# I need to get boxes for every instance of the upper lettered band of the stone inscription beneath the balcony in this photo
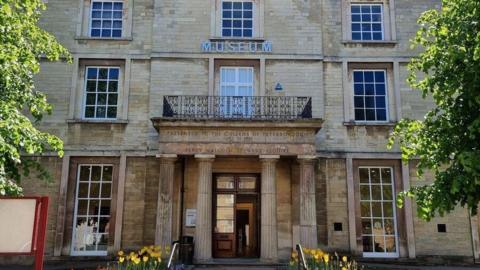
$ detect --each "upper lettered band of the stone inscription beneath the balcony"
[160,129,315,144]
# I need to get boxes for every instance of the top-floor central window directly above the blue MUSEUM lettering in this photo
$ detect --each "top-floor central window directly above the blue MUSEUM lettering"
[221,1,254,37]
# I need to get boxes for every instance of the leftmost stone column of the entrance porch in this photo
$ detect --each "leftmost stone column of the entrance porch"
[155,155,177,247]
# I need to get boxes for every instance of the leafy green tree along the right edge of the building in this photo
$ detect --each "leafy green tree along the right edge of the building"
[389,0,480,220]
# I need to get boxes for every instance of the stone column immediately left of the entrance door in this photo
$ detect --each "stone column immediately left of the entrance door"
[195,155,215,261]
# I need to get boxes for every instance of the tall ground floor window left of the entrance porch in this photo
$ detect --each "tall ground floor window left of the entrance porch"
[71,164,113,256]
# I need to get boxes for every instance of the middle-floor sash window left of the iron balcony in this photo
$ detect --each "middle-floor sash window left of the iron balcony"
[84,66,120,119]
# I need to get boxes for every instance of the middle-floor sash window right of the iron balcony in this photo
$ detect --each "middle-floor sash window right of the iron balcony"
[353,70,388,122]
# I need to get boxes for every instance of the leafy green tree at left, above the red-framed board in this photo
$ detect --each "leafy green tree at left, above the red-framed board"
[0,0,71,196]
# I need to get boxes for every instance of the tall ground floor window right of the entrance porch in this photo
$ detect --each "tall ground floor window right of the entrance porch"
[358,167,399,257]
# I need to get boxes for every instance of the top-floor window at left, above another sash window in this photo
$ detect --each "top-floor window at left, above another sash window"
[90,1,123,38]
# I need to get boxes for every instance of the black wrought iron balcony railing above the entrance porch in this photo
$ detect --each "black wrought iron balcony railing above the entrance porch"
[163,96,312,120]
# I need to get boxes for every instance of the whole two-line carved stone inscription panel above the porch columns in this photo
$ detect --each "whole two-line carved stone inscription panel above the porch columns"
[159,127,315,156]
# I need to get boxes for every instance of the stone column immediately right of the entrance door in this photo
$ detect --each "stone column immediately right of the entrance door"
[260,156,280,261]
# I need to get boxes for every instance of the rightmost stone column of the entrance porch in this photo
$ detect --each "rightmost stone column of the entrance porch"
[298,156,318,248]
